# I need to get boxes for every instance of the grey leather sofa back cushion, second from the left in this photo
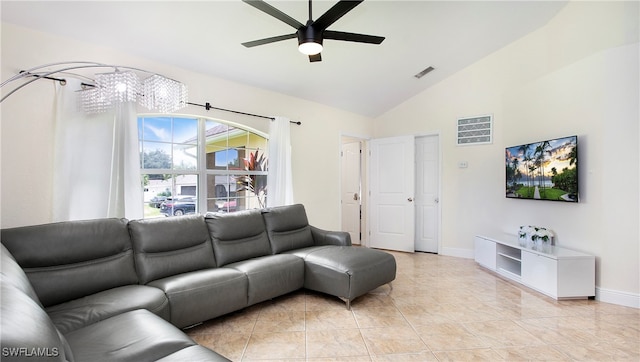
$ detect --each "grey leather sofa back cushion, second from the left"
[129,215,216,284]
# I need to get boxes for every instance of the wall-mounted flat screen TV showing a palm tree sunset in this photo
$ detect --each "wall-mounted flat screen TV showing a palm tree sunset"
[505,136,578,202]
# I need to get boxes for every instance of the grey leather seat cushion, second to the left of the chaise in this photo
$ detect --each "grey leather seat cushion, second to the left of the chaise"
[148,268,248,328]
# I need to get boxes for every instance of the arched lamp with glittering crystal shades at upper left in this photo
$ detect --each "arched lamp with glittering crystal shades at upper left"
[0,61,188,114]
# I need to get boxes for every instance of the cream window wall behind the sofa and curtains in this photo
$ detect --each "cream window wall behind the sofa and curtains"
[0,23,372,230]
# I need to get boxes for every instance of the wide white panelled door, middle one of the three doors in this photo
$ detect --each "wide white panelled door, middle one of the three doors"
[369,136,415,252]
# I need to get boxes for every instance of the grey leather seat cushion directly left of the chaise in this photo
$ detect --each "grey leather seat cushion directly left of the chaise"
[223,254,304,305]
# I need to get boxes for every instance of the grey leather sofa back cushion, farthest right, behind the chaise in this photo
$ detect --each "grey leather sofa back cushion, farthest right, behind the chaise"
[262,204,314,254]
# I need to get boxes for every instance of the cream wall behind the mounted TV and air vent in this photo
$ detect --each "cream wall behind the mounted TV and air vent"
[374,2,640,307]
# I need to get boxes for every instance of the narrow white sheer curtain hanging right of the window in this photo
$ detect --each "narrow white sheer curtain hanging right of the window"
[267,117,293,207]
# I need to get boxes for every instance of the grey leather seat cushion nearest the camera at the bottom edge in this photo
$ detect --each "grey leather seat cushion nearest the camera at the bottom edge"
[66,309,196,362]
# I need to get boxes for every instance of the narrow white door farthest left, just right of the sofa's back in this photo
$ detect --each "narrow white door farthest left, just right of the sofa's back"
[341,142,361,244]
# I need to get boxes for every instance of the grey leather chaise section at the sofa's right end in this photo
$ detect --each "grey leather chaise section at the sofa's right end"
[304,246,396,301]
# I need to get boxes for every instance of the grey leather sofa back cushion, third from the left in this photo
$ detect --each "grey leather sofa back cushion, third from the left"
[205,210,271,266]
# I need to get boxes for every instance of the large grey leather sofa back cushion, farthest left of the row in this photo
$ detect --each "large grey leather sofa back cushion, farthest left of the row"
[1,218,138,307]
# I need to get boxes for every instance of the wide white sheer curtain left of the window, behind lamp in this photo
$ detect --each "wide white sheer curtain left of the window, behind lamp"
[53,79,143,221]
